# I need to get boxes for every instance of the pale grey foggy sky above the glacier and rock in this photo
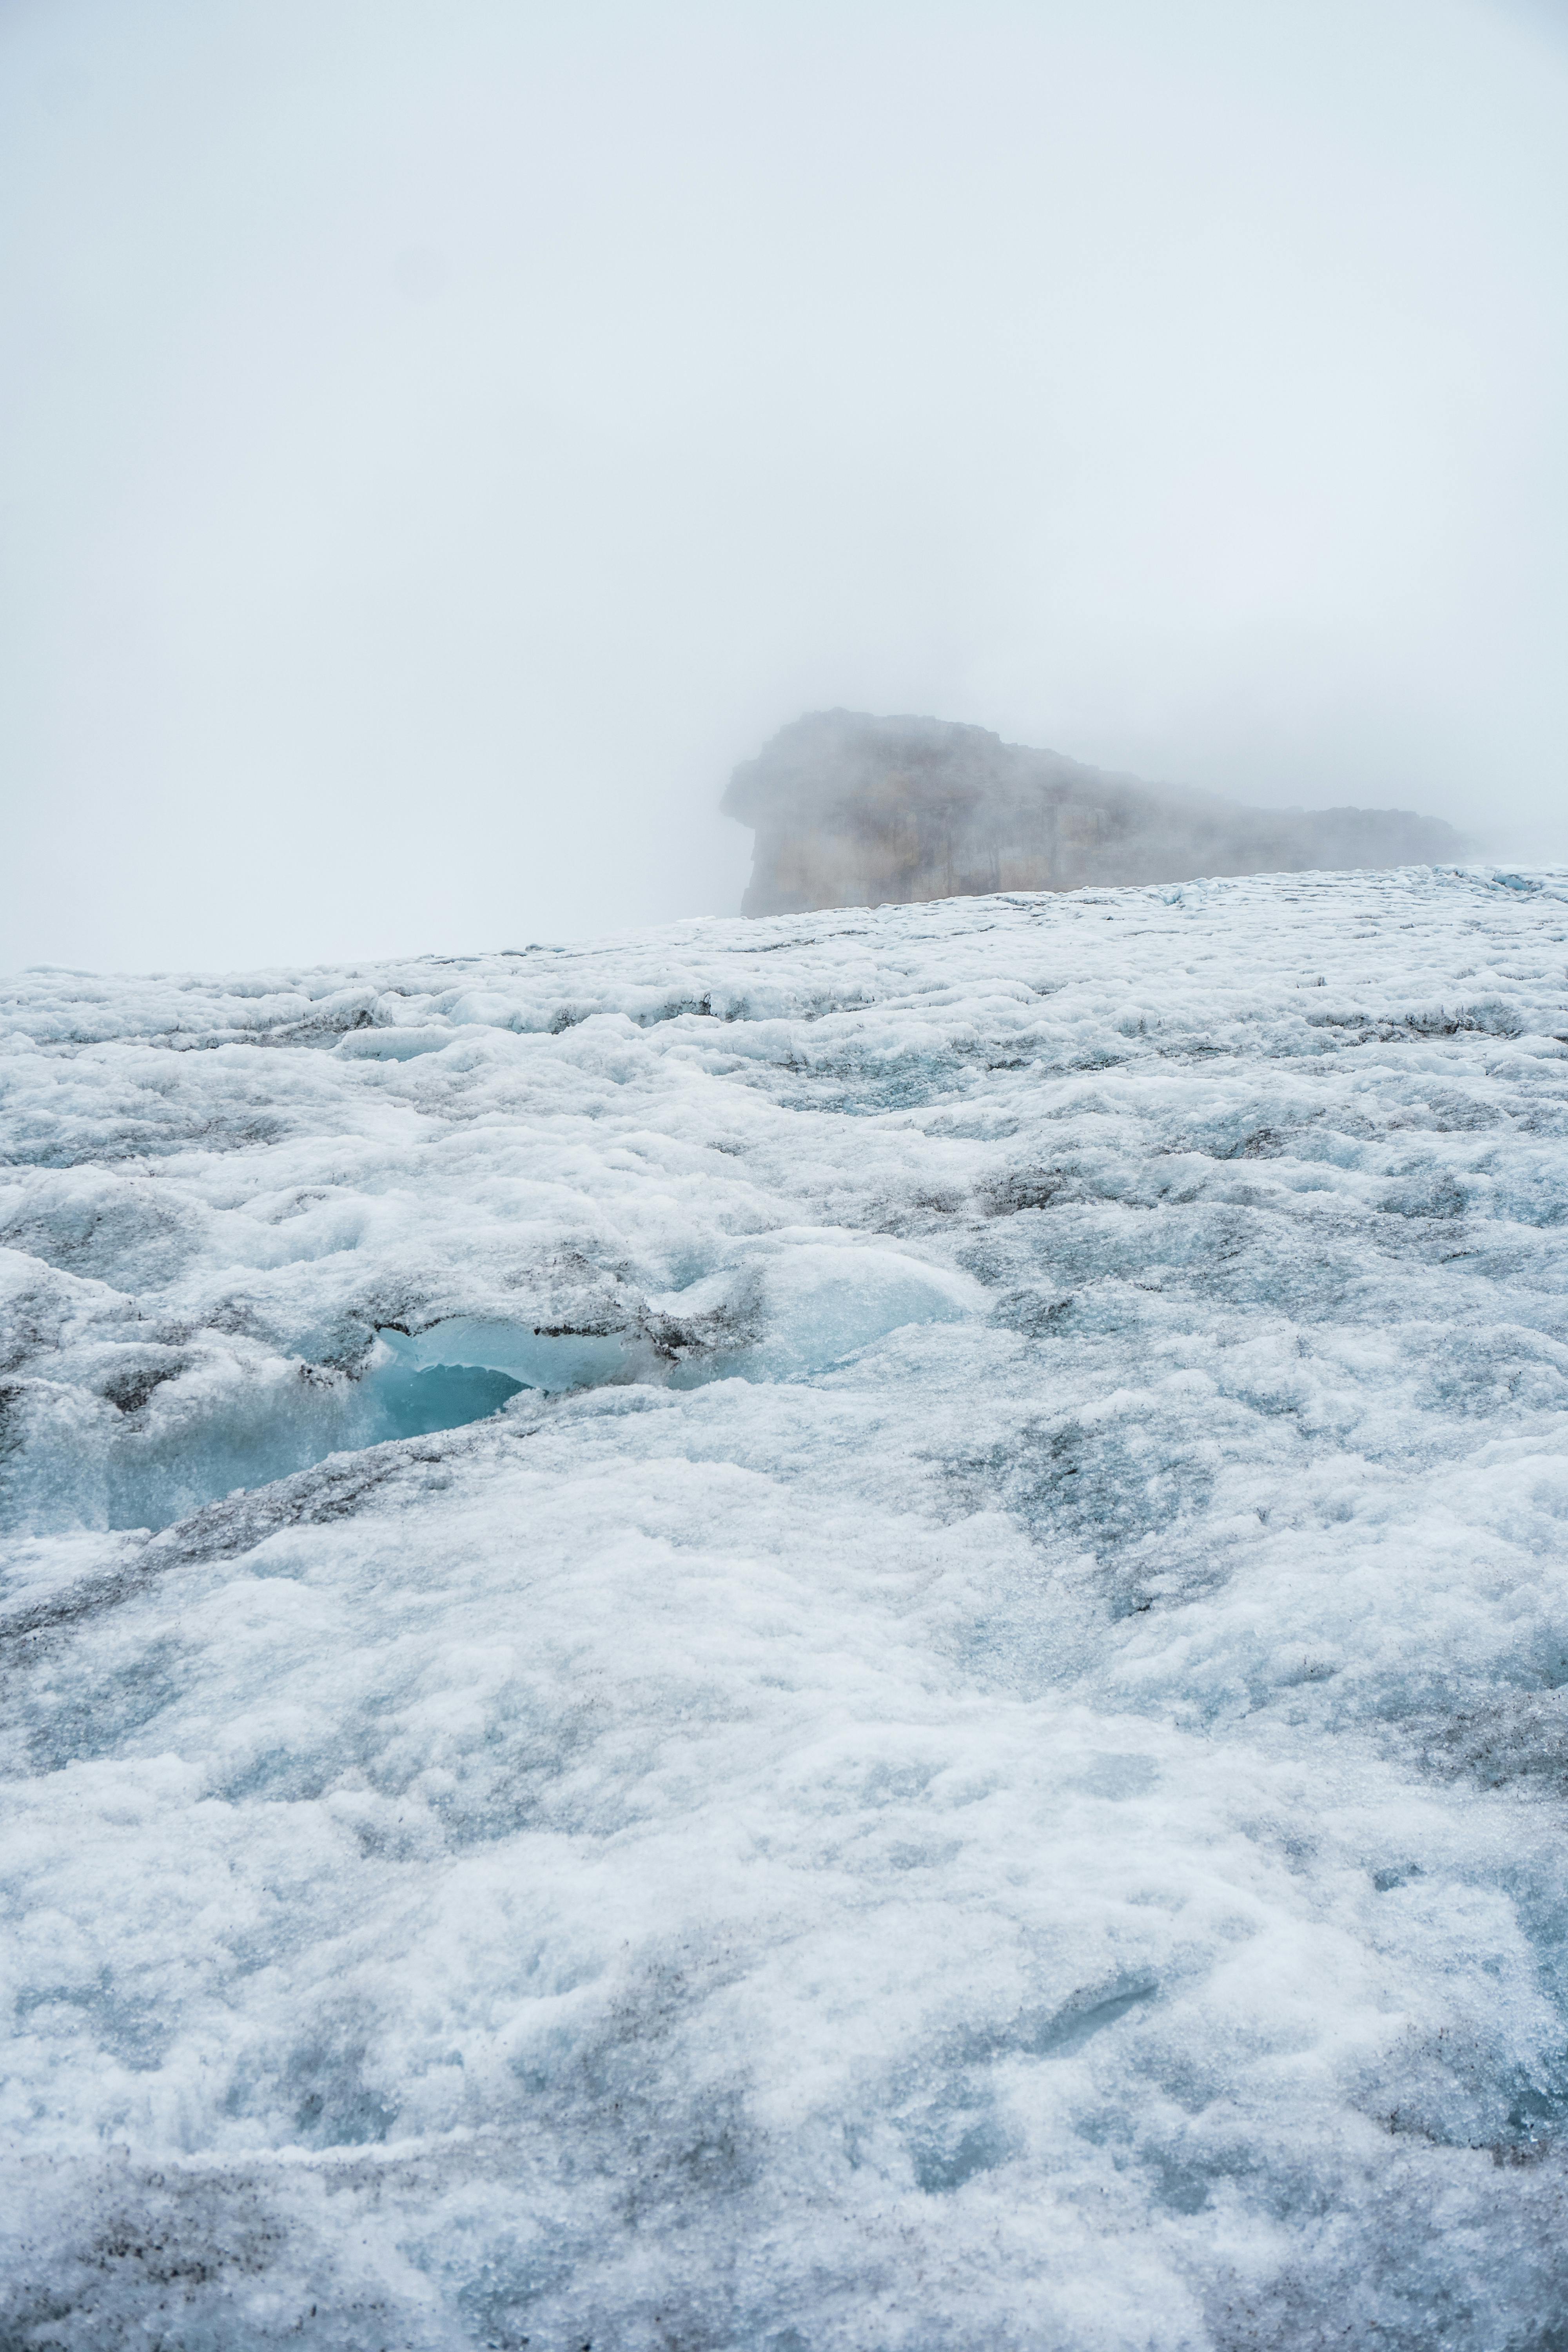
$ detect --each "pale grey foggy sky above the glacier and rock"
[0,0,1568,969]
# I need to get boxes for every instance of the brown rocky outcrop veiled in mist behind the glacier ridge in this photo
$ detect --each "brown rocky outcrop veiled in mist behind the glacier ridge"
[724,710,1462,915]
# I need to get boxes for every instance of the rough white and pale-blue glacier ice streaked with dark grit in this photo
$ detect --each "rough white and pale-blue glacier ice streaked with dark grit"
[0,870,1568,2352]
